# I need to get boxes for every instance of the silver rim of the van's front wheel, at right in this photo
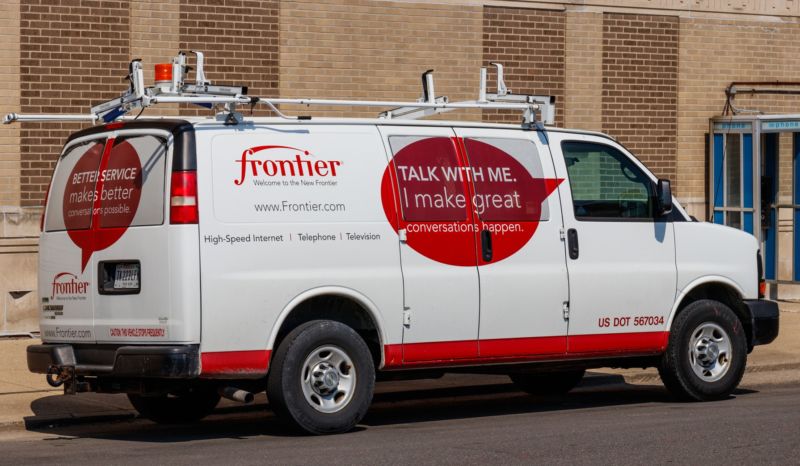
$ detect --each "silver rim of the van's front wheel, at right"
[689,322,733,382]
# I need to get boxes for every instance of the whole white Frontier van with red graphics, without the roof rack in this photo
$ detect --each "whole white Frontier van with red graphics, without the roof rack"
[14,54,778,433]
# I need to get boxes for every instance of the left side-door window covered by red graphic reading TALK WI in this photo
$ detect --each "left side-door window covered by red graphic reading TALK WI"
[389,136,468,222]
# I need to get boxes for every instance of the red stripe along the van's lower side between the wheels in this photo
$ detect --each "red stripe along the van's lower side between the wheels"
[384,332,669,369]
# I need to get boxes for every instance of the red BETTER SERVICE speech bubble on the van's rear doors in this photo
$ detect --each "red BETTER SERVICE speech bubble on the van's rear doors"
[62,140,143,272]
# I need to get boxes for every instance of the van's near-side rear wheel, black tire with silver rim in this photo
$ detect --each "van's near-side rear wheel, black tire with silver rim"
[267,320,375,435]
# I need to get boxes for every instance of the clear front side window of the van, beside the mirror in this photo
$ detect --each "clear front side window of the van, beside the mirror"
[561,141,655,220]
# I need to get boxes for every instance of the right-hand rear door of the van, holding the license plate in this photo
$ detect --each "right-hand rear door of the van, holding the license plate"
[92,131,173,342]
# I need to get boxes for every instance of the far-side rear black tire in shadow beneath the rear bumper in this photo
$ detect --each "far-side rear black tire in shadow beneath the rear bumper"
[128,386,220,424]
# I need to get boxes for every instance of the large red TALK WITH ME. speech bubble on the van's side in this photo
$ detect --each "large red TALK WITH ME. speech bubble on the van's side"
[381,137,563,267]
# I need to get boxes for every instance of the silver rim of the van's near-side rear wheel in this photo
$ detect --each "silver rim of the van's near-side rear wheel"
[300,345,356,413]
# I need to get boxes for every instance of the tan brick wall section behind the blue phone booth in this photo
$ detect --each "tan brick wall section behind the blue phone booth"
[677,18,800,217]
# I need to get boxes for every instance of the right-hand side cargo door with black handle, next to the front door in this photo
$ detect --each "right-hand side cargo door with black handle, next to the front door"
[456,128,569,359]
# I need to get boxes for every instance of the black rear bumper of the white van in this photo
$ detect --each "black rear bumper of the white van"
[28,343,200,379]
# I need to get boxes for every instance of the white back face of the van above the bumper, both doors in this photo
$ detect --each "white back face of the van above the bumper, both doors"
[40,124,199,343]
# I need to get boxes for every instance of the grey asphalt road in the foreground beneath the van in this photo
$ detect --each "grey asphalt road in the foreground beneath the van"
[0,374,800,465]
